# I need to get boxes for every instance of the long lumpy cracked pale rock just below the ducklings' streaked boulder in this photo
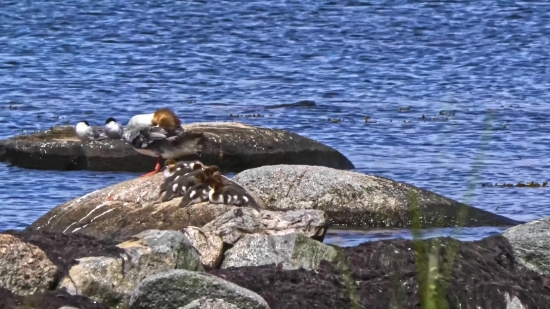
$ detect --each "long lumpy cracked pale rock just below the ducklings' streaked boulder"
[203,207,328,245]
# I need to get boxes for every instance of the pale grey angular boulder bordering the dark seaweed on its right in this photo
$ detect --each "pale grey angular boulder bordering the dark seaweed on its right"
[221,234,337,269]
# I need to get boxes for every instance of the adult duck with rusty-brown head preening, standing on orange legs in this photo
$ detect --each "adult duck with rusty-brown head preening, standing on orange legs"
[122,108,203,177]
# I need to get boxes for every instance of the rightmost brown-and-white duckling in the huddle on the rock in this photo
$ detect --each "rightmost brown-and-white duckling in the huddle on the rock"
[205,177,260,209]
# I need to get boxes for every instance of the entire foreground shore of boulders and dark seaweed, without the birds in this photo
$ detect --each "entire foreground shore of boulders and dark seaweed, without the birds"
[0,162,550,309]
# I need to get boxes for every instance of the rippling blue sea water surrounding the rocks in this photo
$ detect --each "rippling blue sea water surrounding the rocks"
[0,0,550,245]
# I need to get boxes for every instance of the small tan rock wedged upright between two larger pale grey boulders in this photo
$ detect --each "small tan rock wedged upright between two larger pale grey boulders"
[183,226,223,268]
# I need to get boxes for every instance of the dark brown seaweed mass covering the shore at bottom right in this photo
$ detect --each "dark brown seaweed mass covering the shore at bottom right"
[211,236,550,309]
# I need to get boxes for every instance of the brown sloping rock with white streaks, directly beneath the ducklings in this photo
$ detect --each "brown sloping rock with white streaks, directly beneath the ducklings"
[26,173,246,242]
